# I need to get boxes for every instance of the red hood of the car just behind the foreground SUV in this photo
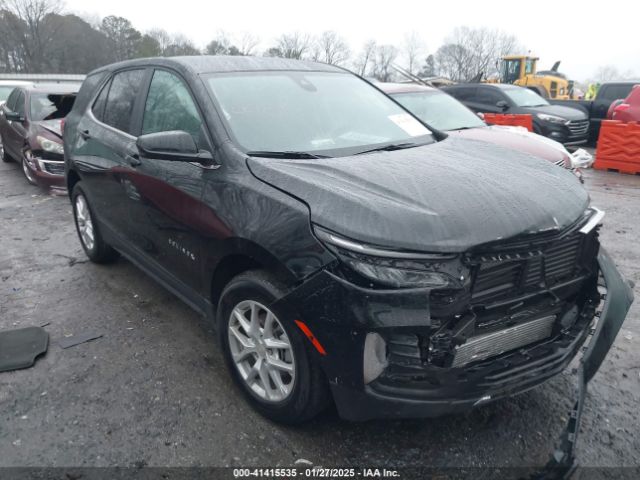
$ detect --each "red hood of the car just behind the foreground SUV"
[447,126,569,163]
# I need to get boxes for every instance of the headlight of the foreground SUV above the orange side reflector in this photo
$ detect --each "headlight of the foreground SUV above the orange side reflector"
[314,226,459,288]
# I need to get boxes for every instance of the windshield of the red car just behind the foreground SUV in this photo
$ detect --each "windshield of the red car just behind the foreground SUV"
[391,91,485,131]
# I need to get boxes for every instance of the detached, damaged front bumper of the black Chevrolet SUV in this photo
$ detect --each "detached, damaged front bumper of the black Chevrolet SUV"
[278,250,633,420]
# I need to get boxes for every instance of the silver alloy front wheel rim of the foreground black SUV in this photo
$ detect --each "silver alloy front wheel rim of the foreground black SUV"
[227,300,296,403]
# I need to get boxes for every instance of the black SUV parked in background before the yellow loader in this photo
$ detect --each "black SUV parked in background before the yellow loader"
[443,83,589,146]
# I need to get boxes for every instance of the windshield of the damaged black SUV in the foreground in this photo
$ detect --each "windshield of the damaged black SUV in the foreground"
[207,71,433,156]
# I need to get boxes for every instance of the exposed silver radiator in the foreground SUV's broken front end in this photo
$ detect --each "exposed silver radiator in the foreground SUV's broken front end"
[452,315,556,367]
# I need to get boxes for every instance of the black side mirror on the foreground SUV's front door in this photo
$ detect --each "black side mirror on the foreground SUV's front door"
[136,130,213,164]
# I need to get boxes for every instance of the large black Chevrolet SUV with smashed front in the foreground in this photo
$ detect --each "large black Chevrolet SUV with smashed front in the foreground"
[64,57,631,422]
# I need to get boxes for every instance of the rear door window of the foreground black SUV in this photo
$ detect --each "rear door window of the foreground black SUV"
[102,69,144,133]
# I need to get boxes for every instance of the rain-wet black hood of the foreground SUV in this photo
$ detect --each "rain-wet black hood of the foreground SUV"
[247,136,589,252]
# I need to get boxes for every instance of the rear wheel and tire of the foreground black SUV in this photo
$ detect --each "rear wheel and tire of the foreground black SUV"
[71,182,119,263]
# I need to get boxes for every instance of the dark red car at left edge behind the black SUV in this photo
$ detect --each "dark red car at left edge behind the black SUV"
[0,84,80,190]
